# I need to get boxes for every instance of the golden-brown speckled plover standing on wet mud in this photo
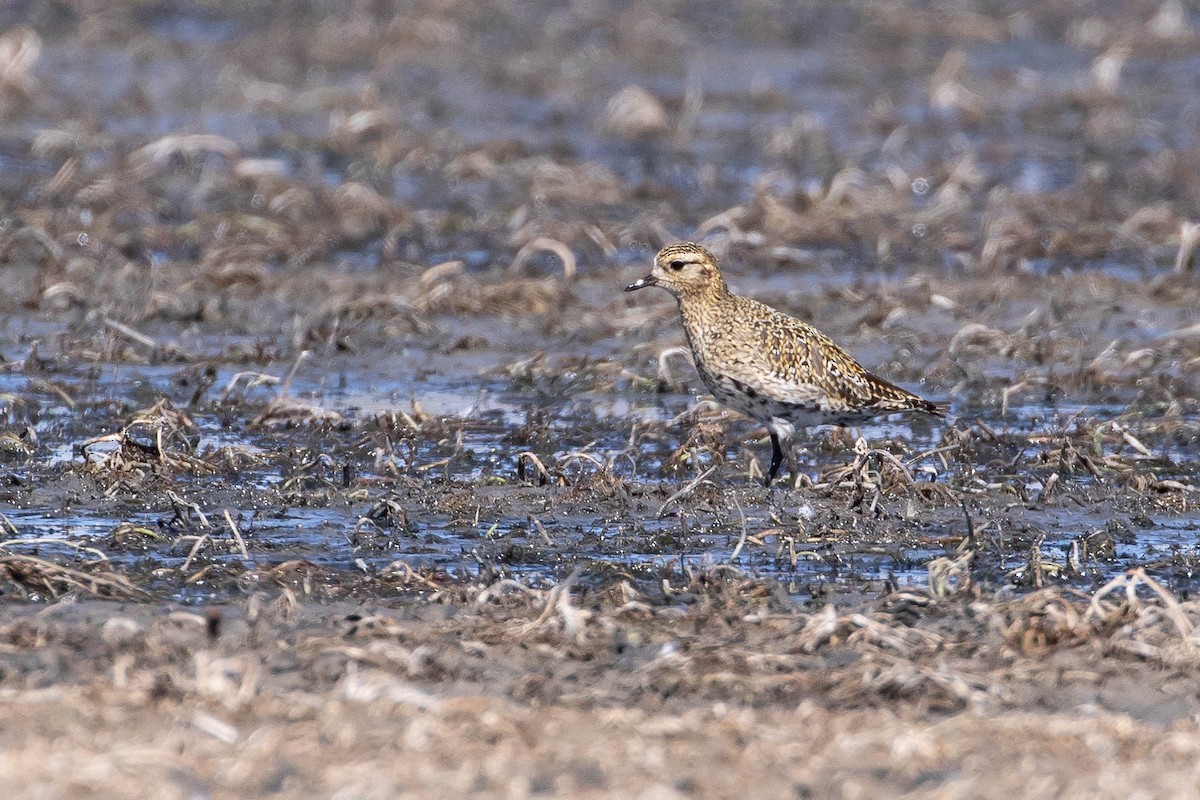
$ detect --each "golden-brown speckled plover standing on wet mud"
[625,242,947,487]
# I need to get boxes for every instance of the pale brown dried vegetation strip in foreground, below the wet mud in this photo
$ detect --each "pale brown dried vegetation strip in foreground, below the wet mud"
[0,570,1200,798]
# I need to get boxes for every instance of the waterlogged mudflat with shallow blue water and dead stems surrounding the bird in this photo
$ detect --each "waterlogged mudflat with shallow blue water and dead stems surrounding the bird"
[0,2,1200,601]
